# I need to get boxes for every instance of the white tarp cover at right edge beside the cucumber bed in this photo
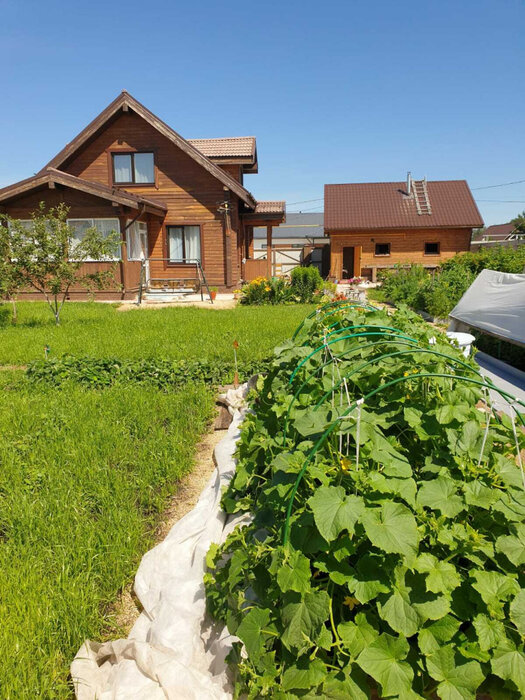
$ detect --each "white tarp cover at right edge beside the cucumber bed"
[449,270,525,345]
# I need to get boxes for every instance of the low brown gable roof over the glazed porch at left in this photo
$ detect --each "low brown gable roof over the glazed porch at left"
[0,168,167,215]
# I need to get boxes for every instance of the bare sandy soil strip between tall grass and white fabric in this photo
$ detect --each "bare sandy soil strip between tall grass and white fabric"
[109,418,226,639]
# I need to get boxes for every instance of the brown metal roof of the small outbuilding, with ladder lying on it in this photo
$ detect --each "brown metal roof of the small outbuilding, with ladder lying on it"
[324,180,483,231]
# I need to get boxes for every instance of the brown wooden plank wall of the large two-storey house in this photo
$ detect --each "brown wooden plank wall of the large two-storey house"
[62,111,242,287]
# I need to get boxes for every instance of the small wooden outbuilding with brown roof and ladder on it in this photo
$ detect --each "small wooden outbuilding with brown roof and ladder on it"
[324,174,483,280]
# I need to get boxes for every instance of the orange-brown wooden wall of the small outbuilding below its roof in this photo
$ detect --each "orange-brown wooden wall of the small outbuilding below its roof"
[328,228,472,279]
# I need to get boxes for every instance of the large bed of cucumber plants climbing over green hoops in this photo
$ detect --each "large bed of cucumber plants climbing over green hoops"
[206,302,525,700]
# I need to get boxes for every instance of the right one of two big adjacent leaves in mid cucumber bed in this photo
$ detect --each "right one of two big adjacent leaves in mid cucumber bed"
[361,501,419,558]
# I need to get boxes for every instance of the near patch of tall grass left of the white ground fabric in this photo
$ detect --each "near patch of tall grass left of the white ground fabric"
[0,377,213,699]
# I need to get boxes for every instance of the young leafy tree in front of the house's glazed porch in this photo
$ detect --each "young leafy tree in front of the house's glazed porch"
[4,202,120,326]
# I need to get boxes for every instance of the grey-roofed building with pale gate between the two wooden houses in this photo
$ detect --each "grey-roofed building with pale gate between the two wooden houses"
[253,212,330,277]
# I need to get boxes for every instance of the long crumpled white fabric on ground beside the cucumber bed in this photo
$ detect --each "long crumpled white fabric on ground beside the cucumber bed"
[71,385,247,700]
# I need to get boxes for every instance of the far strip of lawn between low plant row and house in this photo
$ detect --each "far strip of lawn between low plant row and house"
[0,302,314,365]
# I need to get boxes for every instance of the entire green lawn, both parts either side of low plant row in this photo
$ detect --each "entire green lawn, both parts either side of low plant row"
[0,303,312,700]
